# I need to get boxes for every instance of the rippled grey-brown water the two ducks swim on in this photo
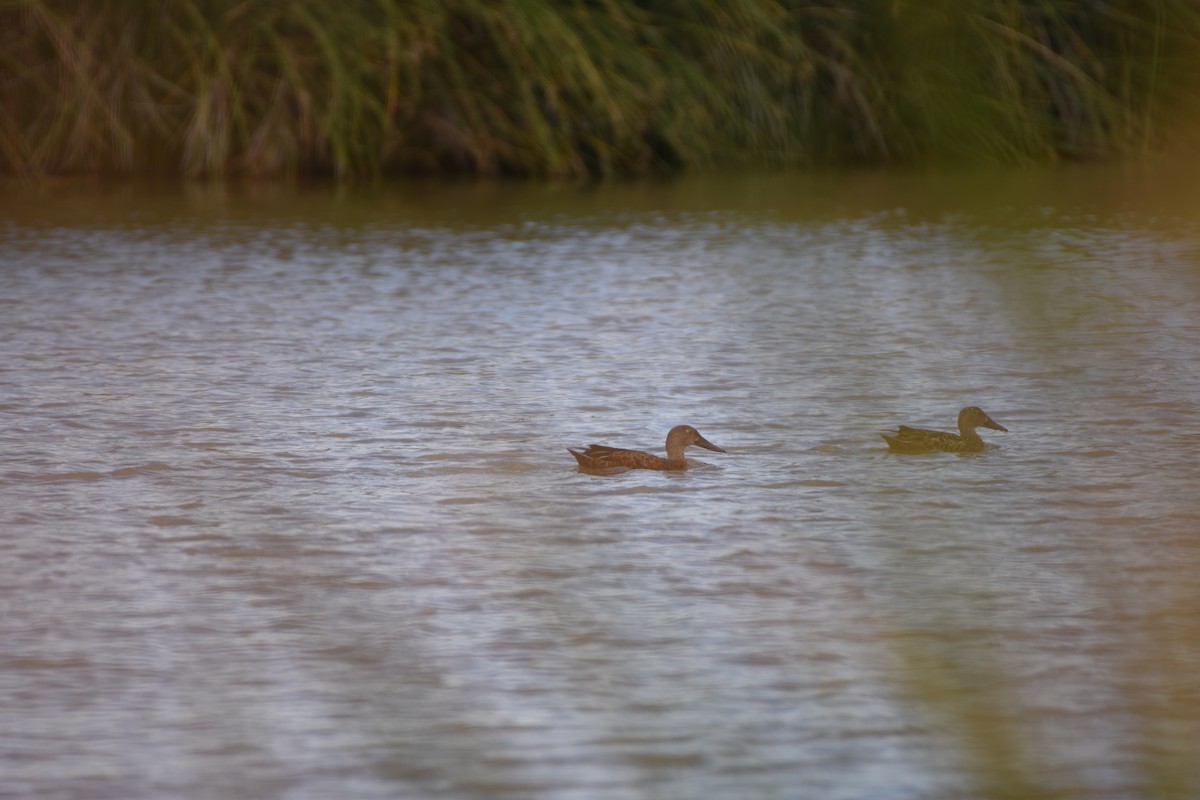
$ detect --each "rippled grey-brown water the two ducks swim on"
[0,167,1200,800]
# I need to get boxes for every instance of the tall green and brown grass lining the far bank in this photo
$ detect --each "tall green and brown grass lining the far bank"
[0,0,1200,176]
